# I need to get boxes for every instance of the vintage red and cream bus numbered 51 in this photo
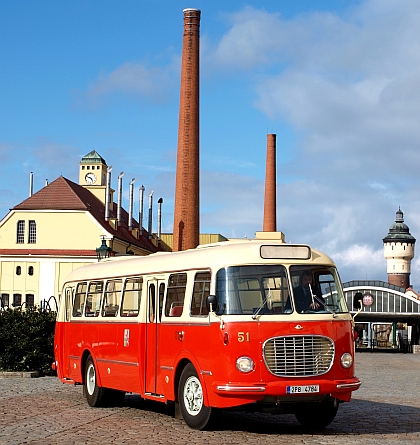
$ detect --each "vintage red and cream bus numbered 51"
[53,240,361,429]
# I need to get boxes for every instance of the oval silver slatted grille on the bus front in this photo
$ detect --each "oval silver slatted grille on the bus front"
[263,335,334,377]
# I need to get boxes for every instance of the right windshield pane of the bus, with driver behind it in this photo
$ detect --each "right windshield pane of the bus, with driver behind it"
[288,266,348,314]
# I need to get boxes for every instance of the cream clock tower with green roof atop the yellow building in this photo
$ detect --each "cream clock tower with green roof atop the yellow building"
[79,150,108,203]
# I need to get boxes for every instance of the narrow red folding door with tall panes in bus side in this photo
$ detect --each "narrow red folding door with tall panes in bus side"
[144,278,165,395]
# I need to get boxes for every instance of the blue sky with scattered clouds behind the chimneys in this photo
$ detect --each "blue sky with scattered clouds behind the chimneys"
[0,0,420,290]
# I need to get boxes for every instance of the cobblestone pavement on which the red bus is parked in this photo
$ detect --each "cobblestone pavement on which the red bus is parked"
[0,353,420,445]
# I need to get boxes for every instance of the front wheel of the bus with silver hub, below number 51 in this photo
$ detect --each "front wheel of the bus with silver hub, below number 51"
[178,363,212,430]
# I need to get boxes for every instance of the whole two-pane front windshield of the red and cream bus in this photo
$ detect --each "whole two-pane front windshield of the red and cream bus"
[216,265,348,317]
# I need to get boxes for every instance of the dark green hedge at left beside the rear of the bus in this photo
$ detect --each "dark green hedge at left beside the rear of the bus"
[0,307,56,375]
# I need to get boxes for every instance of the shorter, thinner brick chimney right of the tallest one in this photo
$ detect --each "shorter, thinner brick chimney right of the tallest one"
[263,134,277,232]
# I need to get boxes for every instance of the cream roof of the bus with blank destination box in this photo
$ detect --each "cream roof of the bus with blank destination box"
[65,239,334,283]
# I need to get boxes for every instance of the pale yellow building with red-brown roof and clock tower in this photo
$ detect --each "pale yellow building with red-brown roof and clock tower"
[0,151,162,309]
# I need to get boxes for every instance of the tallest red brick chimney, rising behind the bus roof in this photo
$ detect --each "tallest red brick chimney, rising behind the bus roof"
[172,9,201,252]
